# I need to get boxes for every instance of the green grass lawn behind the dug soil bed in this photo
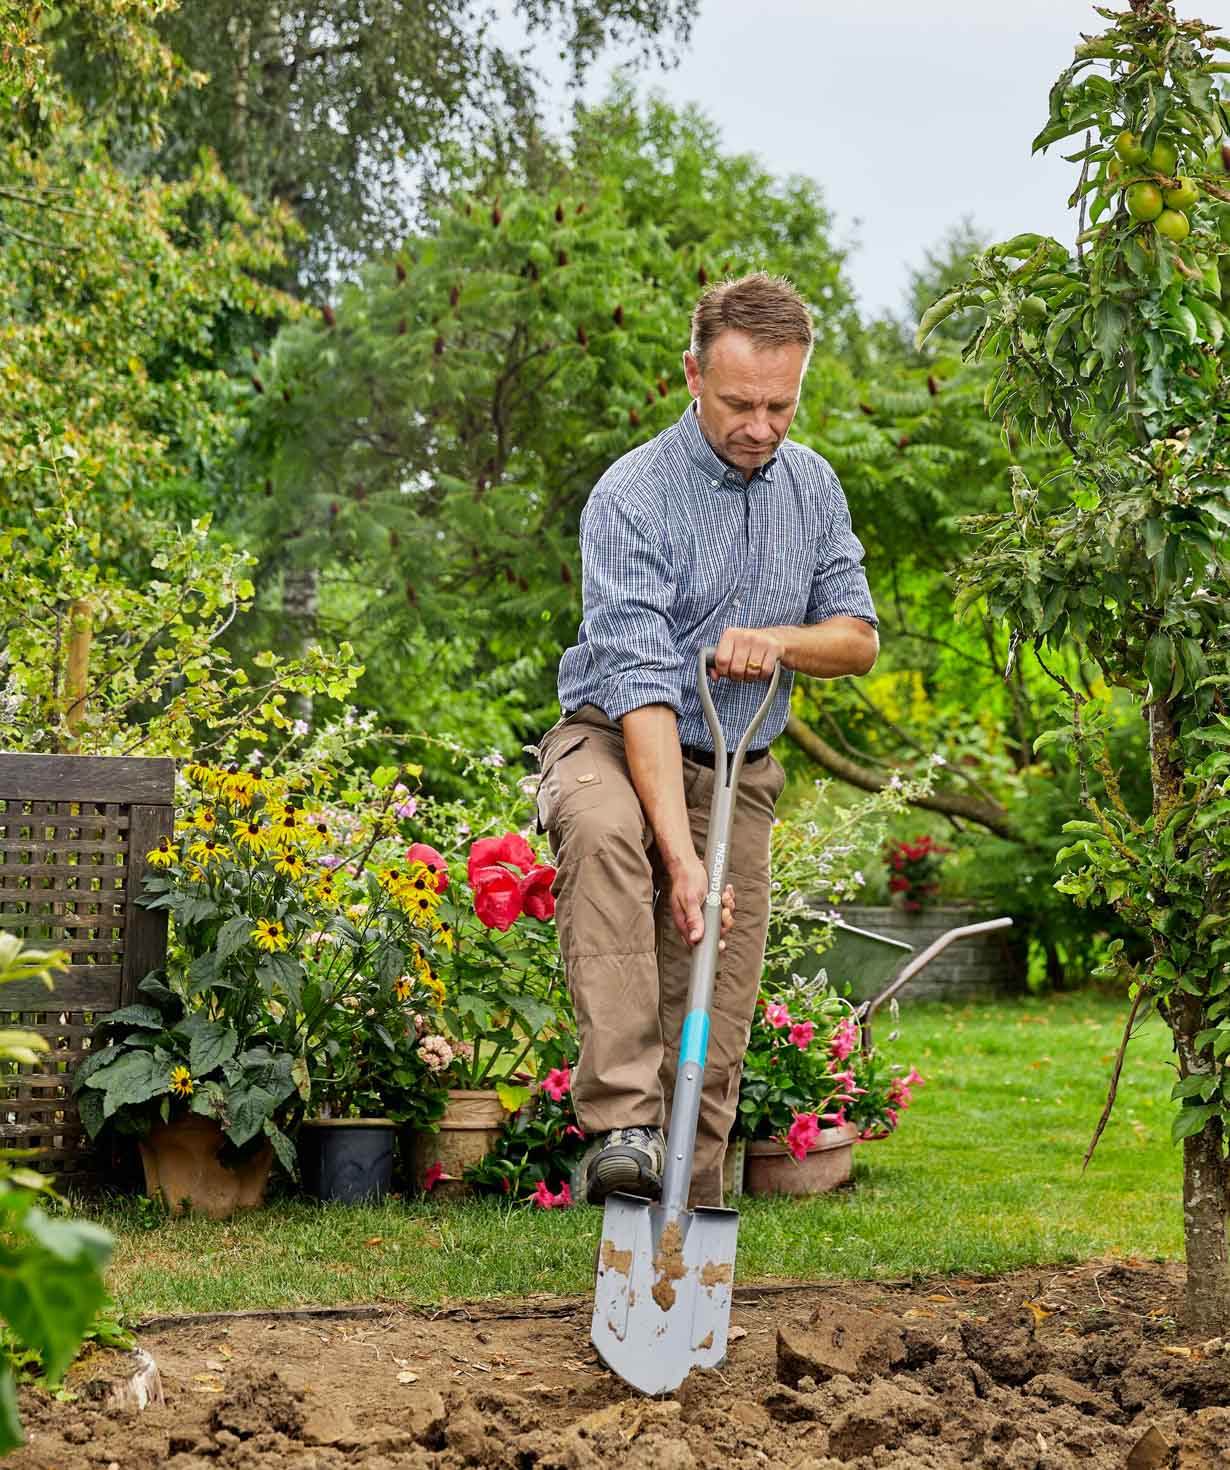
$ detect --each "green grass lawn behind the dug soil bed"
[84,995,1183,1317]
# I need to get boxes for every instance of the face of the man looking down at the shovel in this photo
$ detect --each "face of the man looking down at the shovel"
[683,331,807,475]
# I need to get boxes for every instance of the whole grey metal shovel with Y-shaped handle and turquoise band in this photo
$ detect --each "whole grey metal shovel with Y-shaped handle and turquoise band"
[589,648,782,1394]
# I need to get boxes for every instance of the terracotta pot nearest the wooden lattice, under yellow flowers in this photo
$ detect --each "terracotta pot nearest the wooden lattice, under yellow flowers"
[140,1113,273,1220]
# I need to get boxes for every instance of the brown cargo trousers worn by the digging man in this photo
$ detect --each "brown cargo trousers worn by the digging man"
[538,704,786,1207]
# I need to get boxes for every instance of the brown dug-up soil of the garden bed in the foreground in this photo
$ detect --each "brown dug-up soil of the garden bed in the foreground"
[7,1261,1230,1470]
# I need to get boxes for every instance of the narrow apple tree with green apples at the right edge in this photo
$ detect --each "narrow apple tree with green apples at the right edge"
[918,0,1230,1332]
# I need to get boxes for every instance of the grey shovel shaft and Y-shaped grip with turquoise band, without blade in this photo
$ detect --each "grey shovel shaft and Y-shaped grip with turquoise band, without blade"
[661,648,782,1219]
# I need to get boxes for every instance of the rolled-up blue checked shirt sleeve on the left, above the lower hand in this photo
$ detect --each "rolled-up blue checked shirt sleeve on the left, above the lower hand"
[580,494,683,720]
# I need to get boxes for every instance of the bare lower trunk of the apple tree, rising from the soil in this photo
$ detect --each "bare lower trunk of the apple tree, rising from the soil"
[1167,994,1230,1336]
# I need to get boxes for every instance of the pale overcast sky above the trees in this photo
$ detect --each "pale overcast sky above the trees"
[494,0,1104,323]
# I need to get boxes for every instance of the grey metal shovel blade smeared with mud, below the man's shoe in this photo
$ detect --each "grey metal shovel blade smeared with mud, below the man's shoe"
[589,1194,739,1394]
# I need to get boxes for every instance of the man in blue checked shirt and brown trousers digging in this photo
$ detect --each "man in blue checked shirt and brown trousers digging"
[538,275,879,1207]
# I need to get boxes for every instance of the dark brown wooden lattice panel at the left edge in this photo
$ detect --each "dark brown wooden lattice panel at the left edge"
[0,753,175,1185]
